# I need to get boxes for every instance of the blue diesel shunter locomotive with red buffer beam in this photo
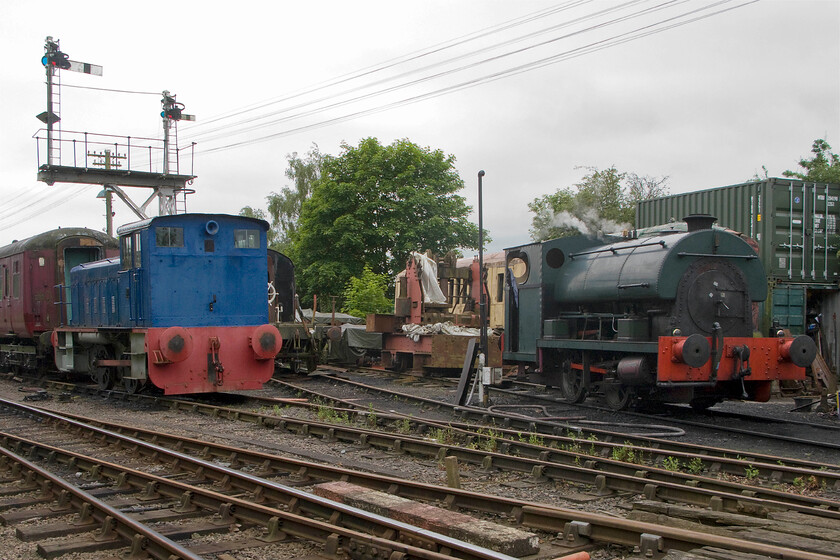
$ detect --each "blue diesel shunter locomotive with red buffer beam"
[53,214,282,394]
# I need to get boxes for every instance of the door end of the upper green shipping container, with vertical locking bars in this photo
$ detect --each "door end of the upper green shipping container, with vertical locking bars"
[767,181,840,282]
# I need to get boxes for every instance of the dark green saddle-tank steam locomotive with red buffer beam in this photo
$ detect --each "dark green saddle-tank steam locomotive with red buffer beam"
[504,215,816,409]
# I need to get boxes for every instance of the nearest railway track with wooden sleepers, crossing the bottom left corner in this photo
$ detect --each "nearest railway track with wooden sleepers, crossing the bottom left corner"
[0,401,528,560]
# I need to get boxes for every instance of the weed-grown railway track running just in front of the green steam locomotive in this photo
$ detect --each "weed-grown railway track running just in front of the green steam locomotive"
[13,382,840,500]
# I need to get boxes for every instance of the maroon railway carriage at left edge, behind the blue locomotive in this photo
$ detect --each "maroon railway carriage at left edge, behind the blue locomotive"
[0,228,118,372]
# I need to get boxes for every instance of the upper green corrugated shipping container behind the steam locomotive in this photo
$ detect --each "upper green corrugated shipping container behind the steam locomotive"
[636,178,840,285]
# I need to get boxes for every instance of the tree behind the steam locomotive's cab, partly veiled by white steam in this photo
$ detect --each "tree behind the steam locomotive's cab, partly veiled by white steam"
[528,166,668,241]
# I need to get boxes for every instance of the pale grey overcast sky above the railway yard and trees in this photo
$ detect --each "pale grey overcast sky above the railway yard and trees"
[0,0,840,251]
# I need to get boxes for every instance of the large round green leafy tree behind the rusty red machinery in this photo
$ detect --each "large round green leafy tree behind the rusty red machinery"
[290,138,478,308]
